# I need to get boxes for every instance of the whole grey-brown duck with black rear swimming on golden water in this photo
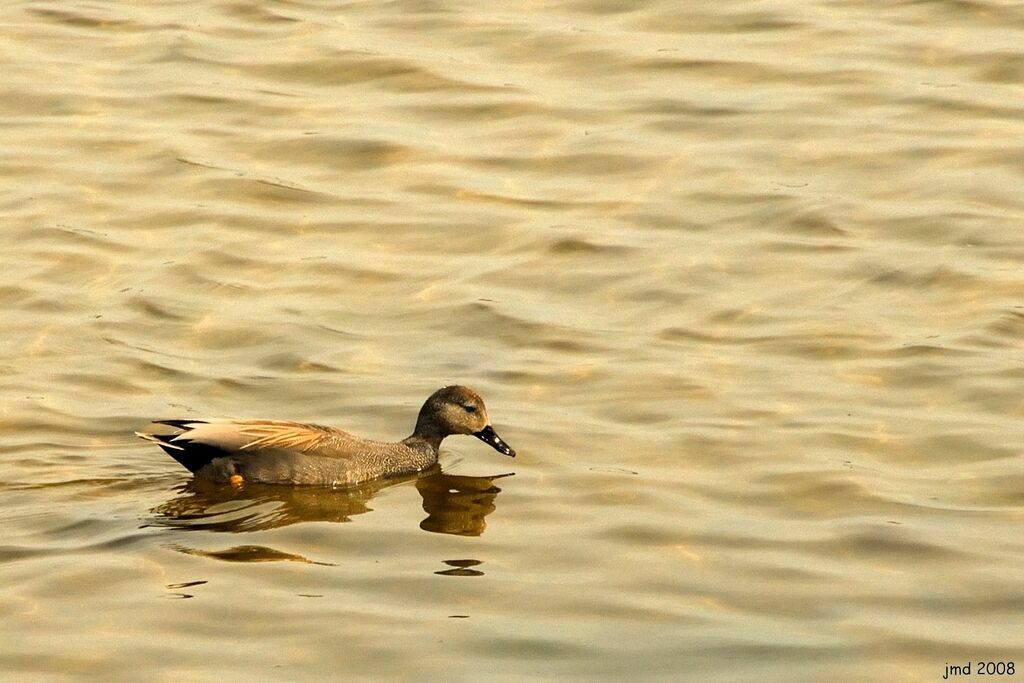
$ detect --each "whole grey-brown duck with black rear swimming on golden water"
[135,386,515,486]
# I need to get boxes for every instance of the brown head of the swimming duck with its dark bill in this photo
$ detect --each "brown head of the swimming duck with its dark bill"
[413,385,515,458]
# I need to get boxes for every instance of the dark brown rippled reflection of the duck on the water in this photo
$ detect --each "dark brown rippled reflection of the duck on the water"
[151,465,511,536]
